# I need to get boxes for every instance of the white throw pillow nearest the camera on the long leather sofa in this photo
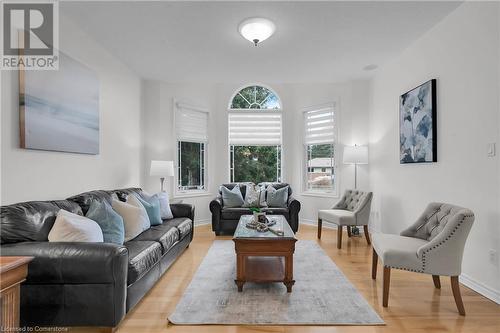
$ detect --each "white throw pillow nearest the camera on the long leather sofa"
[49,209,104,243]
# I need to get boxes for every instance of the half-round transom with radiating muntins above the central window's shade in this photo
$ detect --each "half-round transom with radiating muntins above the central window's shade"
[230,86,281,110]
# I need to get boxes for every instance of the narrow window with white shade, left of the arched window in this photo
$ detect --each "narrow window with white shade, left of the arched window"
[175,103,208,192]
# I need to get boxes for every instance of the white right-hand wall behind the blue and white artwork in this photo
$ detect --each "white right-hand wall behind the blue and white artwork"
[369,3,500,302]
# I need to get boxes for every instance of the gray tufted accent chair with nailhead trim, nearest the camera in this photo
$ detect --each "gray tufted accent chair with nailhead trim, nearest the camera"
[372,203,474,316]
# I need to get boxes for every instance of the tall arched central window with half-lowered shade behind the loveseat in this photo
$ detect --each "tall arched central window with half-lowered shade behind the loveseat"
[228,85,282,184]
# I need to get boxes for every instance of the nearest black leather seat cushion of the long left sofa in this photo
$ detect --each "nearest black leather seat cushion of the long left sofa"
[123,239,162,285]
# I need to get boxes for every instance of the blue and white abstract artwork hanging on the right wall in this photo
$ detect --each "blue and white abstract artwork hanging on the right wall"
[399,79,437,164]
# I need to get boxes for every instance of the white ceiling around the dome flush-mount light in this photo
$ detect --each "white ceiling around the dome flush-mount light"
[60,1,460,83]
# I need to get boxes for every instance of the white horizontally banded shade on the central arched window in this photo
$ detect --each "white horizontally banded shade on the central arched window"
[229,111,281,146]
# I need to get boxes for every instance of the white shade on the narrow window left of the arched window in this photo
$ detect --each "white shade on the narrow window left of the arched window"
[175,103,208,142]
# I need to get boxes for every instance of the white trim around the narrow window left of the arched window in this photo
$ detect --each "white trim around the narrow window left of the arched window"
[172,98,210,199]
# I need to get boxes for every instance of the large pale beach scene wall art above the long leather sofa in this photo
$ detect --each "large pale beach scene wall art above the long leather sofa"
[19,52,99,154]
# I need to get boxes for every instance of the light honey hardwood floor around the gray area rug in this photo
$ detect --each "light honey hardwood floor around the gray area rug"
[71,225,500,333]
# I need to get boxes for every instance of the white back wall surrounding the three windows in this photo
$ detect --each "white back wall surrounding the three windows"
[142,81,369,223]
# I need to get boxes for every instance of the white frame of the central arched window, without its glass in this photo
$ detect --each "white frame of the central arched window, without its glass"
[226,83,284,182]
